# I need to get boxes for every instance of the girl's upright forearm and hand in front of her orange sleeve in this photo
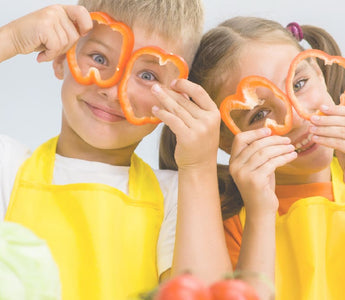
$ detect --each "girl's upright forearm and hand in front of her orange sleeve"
[230,128,297,299]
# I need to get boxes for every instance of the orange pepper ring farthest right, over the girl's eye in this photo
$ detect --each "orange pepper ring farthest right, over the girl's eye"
[286,49,345,120]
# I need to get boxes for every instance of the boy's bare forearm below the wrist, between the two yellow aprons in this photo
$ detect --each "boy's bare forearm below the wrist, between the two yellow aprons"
[172,164,232,283]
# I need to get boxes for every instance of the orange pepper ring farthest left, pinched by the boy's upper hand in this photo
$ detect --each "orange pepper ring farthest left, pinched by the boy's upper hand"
[66,12,134,88]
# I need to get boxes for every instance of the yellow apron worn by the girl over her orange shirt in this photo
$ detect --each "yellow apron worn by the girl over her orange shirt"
[240,159,345,300]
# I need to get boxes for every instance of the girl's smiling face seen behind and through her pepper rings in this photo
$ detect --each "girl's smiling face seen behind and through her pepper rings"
[217,42,333,179]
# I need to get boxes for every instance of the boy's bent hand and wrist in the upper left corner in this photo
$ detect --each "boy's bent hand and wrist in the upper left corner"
[0,5,93,62]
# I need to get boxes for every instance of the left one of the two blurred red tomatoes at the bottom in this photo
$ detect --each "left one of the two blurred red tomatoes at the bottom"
[153,274,212,300]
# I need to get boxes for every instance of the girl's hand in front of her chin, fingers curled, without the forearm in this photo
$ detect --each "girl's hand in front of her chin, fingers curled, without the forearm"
[229,128,297,216]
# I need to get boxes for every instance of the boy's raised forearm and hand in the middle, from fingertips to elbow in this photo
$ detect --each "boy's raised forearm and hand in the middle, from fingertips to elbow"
[153,80,232,283]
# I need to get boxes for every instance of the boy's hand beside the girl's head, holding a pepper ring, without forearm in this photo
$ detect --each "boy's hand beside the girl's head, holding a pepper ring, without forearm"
[153,79,220,170]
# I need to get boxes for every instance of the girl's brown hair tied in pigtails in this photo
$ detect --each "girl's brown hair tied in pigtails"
[159,17,345,219]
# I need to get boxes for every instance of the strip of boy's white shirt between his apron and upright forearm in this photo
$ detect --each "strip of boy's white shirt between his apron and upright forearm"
[155,170,178,276]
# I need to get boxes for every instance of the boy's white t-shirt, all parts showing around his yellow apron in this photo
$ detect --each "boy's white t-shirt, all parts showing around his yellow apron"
[0,135,178,275]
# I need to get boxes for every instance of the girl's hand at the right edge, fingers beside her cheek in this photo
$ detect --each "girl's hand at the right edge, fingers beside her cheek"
[310,105,345,182]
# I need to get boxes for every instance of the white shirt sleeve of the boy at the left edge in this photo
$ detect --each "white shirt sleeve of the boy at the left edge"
[0,134,30,220]
